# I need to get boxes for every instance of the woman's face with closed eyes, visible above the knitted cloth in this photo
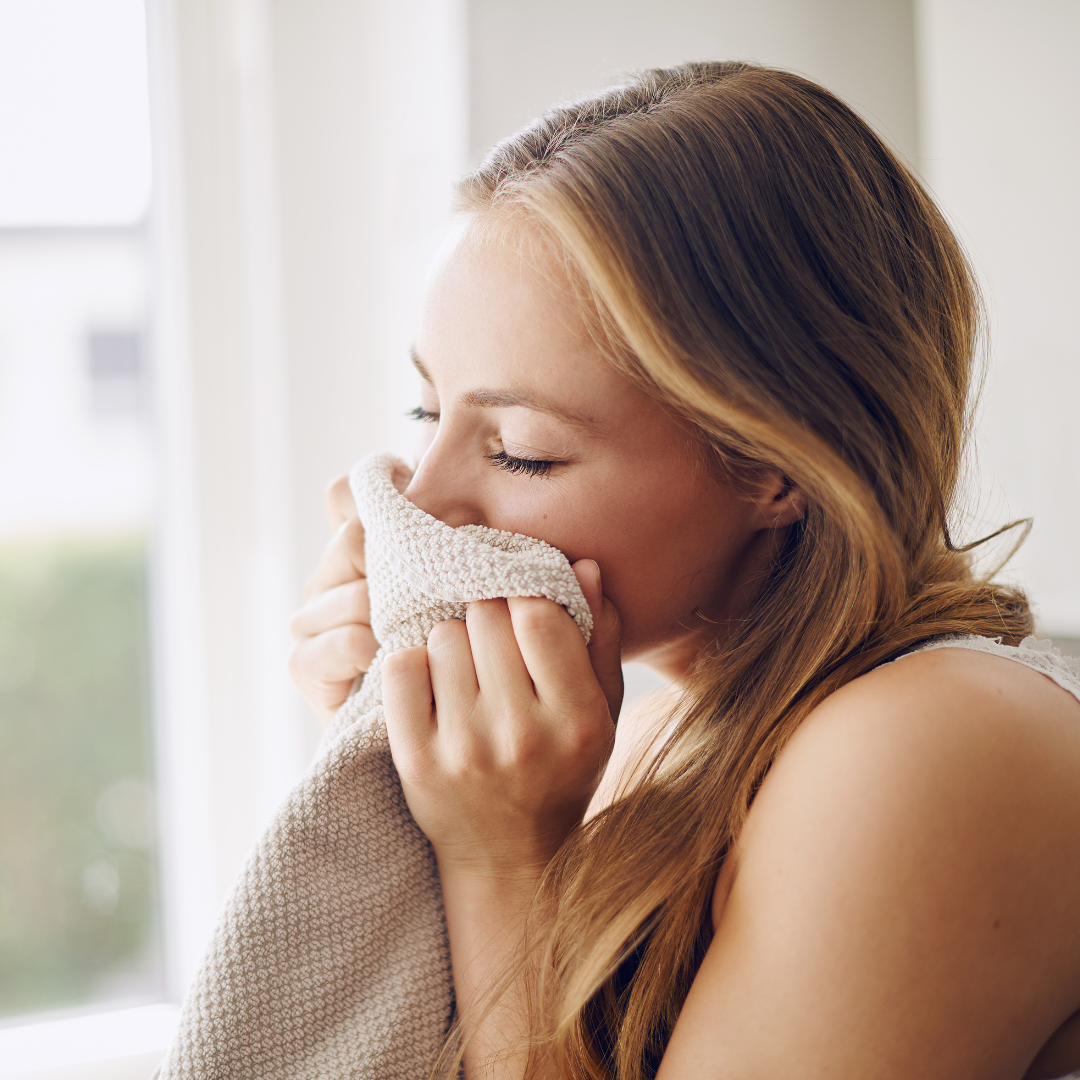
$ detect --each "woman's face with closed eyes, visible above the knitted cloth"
[405,224,766,677]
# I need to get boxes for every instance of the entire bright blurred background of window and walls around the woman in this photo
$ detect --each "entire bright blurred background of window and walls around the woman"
[0,0,1080,1080]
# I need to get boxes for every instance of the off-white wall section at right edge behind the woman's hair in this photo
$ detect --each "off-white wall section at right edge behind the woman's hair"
[918,0,1080,637]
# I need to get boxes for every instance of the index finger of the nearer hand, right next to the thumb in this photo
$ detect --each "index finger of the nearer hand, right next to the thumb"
[507,596,596,705]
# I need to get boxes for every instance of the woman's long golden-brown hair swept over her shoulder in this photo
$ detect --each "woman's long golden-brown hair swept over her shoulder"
[447,63,1031,1080]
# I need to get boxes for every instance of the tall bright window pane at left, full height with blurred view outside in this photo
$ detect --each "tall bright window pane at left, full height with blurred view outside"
[0,0,163,1016]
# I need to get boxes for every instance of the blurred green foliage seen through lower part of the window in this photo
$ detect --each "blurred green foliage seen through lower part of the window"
[0,540,161,1015]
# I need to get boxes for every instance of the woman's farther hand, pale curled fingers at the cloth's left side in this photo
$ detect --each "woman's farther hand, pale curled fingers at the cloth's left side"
[288,476,379,724]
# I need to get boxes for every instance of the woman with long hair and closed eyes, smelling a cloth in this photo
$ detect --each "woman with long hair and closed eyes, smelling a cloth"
[293,64,1080,1080]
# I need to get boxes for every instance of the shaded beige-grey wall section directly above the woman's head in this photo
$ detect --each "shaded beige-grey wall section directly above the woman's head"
[469,0,918,162]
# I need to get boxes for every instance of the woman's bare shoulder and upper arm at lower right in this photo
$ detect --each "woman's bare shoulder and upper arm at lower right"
[660,650,1080,1080]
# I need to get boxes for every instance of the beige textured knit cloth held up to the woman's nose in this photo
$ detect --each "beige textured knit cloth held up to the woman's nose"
[158,455,592,1080]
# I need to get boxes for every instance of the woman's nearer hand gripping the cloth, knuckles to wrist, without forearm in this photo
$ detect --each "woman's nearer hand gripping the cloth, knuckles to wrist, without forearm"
[382,559,622,877]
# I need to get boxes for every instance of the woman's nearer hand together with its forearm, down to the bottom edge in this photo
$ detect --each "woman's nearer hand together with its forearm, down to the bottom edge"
[382,559,622,1078]
